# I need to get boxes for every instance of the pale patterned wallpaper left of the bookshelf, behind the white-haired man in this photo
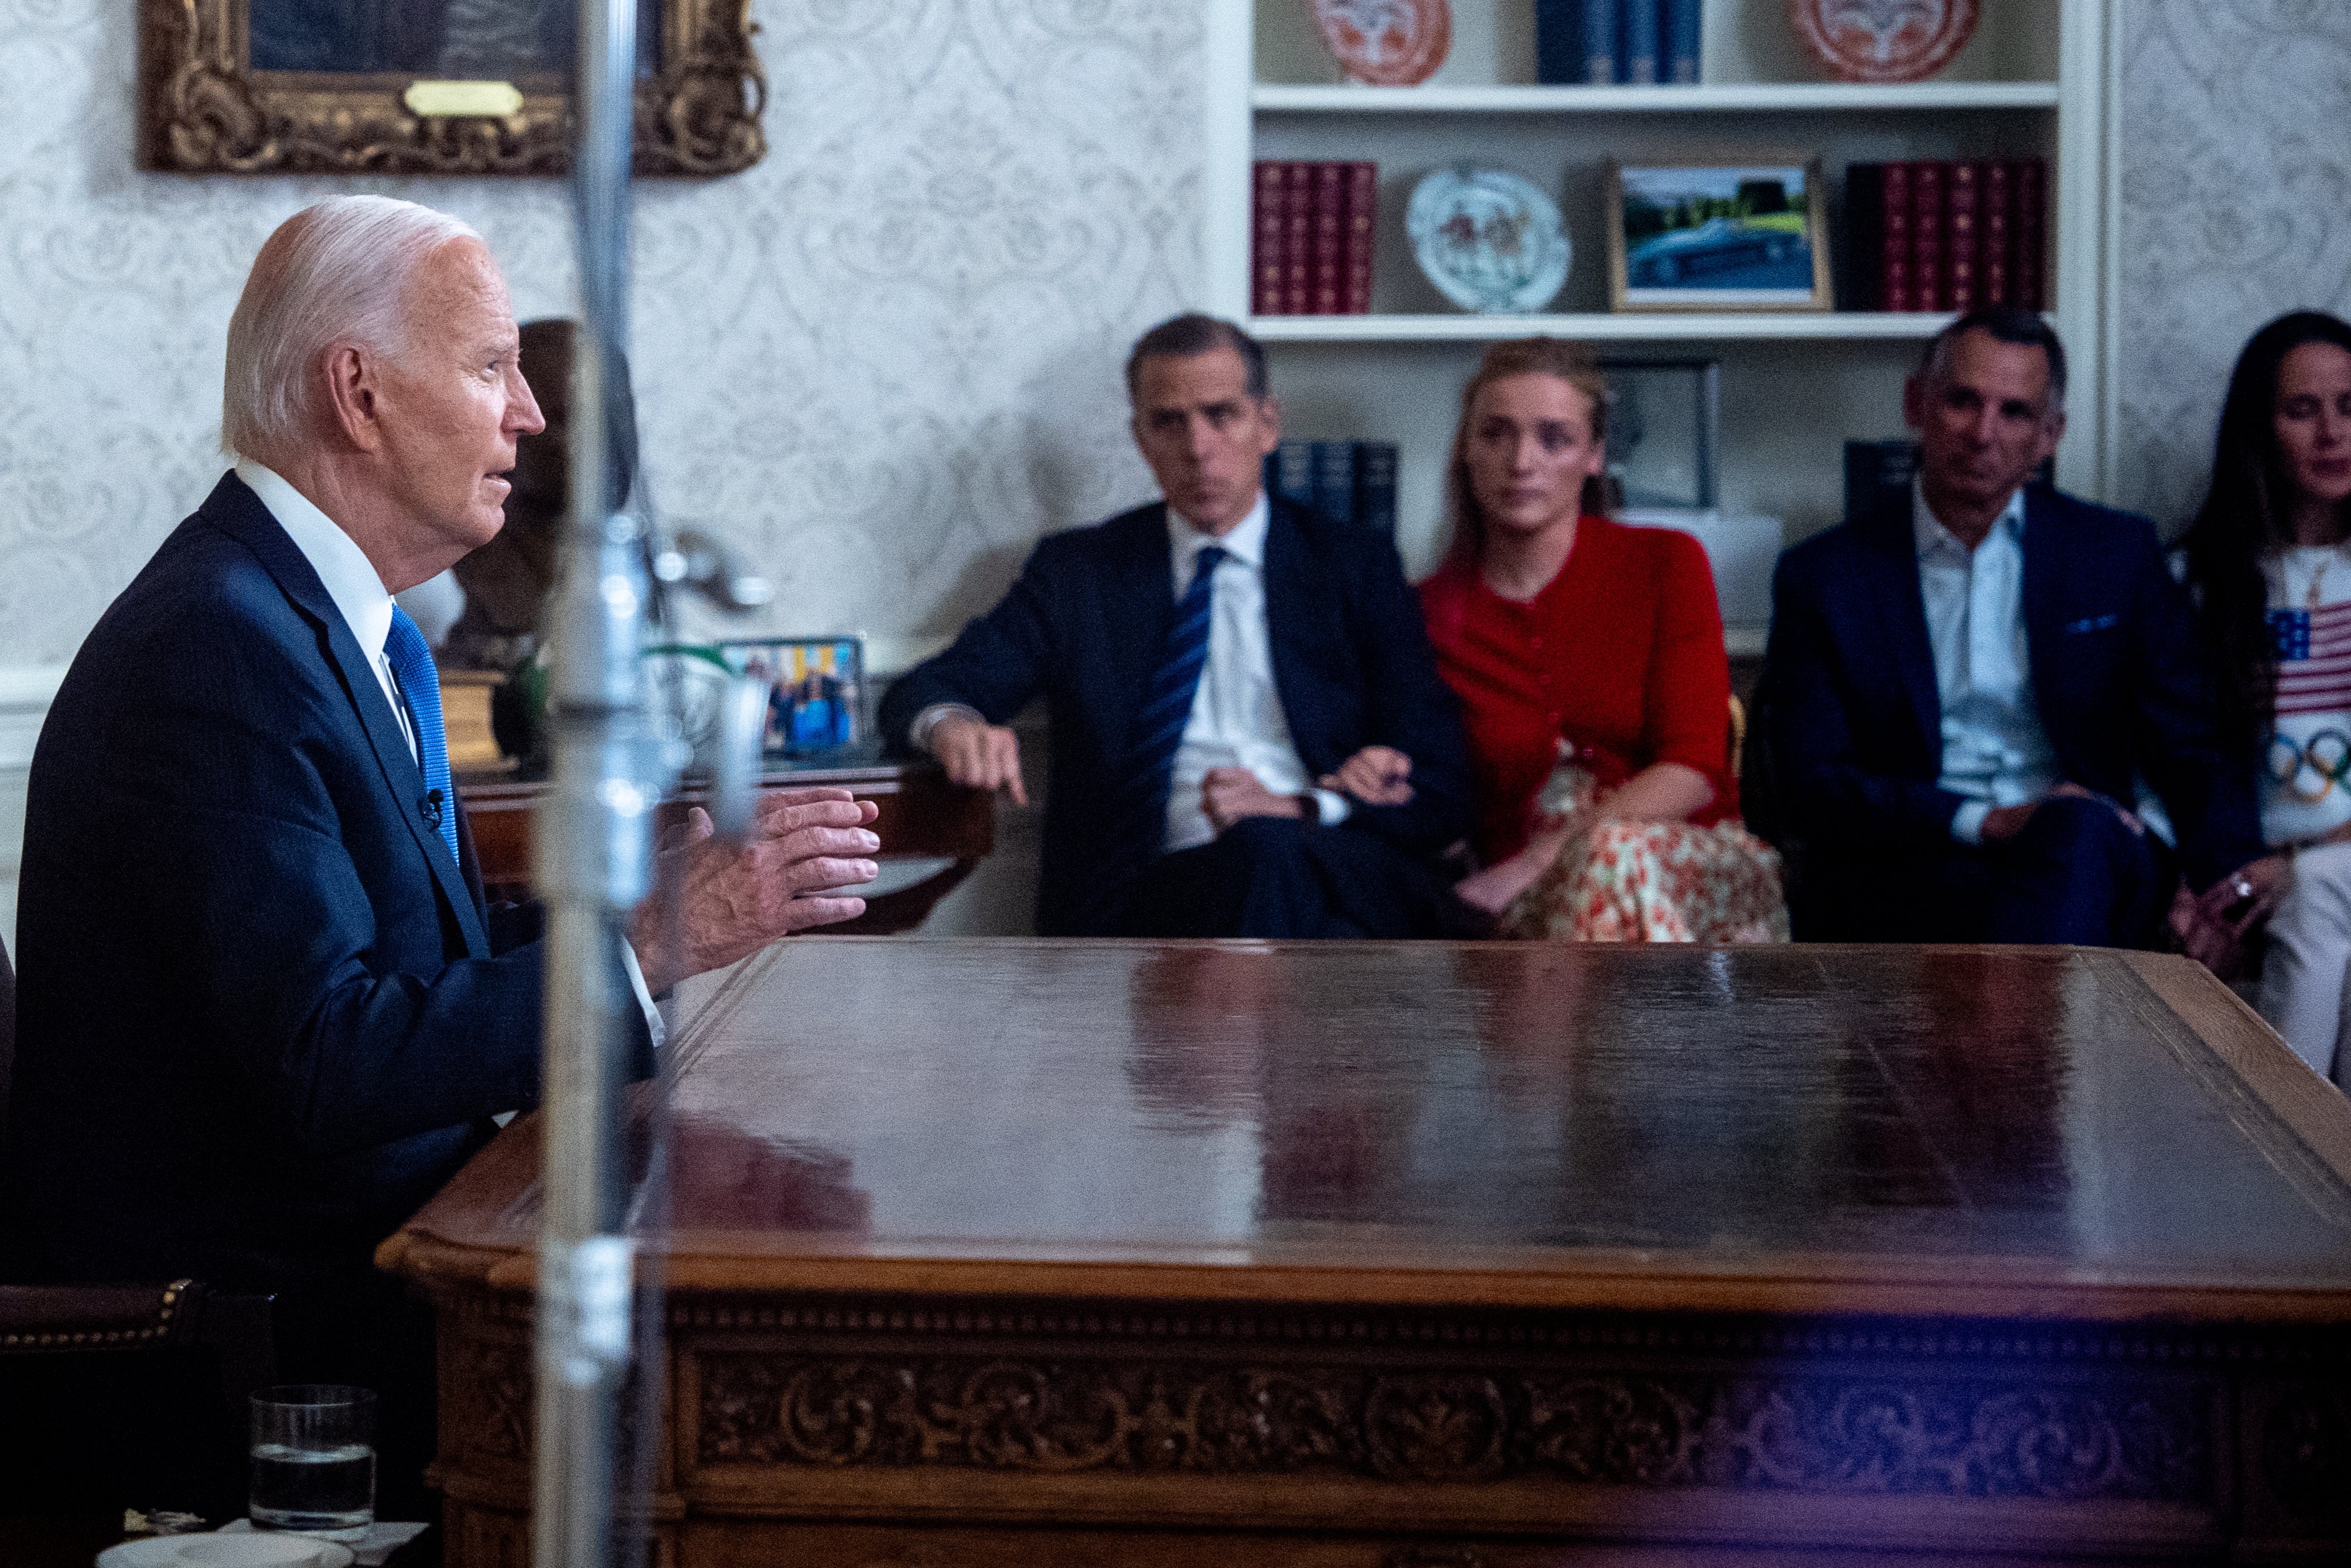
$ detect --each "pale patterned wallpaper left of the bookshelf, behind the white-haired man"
[0,0,1202,668]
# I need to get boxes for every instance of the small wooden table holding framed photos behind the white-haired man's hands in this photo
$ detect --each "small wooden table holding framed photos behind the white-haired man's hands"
[459,757,997,935]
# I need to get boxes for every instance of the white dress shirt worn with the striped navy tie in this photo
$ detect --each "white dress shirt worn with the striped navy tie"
[1166,489,1347,853]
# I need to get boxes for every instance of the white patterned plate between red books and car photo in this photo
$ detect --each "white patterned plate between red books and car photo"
[1404,167,1573,315]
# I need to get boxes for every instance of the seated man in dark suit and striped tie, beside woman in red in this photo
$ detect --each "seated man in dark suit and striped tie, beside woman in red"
[882,315,1472,938]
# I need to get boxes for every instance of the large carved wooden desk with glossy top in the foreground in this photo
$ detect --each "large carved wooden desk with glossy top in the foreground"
[383,940,2351,1568]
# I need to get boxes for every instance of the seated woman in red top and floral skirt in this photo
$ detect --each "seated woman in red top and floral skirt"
[1352,339,1787,940]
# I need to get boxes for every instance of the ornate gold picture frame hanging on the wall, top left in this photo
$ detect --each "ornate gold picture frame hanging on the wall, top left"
[139,0,766,176]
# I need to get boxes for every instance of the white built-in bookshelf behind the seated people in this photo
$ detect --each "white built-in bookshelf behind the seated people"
[1204,0,2118,595]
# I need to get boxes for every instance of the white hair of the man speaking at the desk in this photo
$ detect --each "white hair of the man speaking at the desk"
[221,195,482,463]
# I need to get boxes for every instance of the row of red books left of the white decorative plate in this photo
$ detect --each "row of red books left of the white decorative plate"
[1248,160,1380,315]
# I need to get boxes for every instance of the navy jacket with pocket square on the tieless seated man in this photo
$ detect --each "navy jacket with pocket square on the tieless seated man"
[1763,484,2264,889]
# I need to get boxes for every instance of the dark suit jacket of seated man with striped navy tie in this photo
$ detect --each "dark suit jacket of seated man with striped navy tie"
[882,498,1469,935]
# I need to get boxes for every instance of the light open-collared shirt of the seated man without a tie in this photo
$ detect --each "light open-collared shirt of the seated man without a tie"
[1912,480,2057,844]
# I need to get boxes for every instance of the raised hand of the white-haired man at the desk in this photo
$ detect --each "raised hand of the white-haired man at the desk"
[630,790,882,995]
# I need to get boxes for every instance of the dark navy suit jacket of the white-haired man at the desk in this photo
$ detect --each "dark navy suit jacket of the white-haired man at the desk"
[7,475,649,1300]
